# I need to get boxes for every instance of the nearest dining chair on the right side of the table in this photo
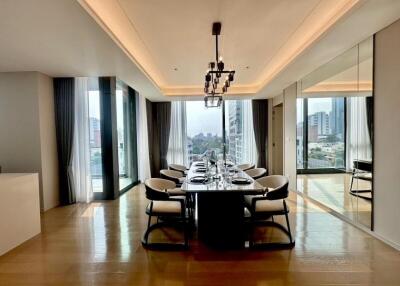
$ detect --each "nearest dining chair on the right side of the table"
[245,175,295,248]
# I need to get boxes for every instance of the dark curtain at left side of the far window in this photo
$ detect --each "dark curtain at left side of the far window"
[146,100,171,177]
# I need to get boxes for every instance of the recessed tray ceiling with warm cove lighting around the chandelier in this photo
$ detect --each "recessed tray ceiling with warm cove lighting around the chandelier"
[80,0,360,95]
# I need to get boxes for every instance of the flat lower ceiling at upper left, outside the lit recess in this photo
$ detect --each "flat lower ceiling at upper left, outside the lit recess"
[0,0,162,100]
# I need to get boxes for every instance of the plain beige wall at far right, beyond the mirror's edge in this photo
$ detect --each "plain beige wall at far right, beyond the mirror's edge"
[374,21,400,248]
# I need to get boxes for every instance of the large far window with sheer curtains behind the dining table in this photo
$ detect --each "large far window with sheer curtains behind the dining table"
[168,100,257,165]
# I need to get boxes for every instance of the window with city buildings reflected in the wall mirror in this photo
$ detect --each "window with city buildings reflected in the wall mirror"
[297,97,346,170]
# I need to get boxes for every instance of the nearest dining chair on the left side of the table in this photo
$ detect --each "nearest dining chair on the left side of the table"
[142,178,189,249]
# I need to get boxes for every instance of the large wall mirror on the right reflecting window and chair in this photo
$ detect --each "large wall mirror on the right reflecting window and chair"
[296,38,373,228]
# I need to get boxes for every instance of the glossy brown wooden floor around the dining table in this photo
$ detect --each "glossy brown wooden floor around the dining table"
[0,184,400,286]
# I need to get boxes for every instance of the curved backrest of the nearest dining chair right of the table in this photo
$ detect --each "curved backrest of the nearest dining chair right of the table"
[257,175,289,200]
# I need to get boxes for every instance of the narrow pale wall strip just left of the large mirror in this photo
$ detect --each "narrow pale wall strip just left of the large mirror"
[283,83,297,191]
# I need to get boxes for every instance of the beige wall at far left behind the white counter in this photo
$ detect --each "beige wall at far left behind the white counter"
[0,72,58,211]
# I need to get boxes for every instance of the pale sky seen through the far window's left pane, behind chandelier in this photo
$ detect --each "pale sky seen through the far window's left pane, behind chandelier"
[186,101,222,137]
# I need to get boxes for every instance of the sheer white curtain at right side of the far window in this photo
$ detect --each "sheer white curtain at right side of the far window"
[243,100,257,164]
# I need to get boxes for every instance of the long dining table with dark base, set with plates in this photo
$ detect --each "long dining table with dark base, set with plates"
[181,162,265,249]
